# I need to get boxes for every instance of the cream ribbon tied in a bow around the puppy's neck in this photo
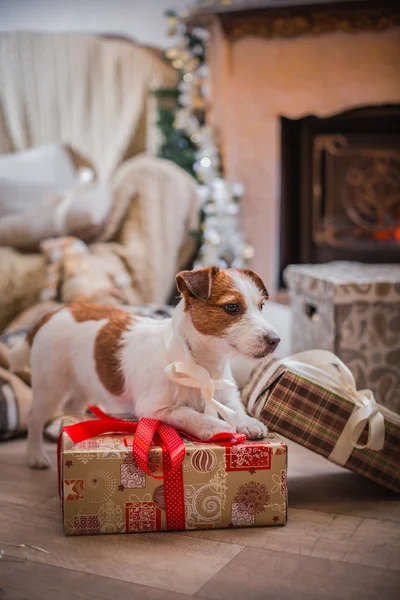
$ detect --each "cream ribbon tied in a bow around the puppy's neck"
[164,305,236,427]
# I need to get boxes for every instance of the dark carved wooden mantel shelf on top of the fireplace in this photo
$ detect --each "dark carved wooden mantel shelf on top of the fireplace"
[186,0,400,40]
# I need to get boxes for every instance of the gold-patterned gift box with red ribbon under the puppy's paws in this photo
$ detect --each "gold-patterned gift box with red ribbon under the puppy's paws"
[59,408,287,535]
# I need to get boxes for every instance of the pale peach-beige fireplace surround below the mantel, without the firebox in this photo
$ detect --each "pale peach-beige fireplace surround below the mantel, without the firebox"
[189,2,400,294]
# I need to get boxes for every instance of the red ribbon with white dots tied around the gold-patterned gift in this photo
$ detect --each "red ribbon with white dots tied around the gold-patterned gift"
[58,406,246,529]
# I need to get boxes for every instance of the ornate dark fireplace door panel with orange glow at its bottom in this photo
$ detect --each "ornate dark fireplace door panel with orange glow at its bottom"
[312,134,400,251]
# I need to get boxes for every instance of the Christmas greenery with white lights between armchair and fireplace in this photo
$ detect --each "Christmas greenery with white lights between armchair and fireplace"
[154,11,254,268]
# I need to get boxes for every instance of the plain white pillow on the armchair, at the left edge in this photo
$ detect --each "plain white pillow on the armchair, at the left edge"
[0,144,76,189]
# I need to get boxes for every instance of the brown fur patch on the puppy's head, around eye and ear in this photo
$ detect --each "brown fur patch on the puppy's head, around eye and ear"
[177,267,247,337]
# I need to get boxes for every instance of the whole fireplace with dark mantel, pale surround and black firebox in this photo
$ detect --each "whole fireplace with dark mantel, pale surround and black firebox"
[188,0,400,295]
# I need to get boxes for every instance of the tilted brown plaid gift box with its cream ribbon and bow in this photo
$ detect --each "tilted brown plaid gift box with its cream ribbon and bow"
[242,350,400,493]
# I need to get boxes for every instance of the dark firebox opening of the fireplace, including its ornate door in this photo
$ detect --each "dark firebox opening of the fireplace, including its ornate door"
[279,105,400,285]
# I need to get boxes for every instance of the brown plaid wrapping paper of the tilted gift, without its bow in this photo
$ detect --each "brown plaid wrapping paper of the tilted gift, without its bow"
[242,351,400,493]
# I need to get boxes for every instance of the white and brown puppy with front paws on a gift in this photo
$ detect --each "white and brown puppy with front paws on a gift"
[11,267,280,468]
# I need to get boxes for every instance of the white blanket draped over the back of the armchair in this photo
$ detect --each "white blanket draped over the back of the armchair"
[0,32,175,179]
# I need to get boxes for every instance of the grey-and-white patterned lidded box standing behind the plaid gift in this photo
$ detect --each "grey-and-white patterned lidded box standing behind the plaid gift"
[284,262,400,413]
